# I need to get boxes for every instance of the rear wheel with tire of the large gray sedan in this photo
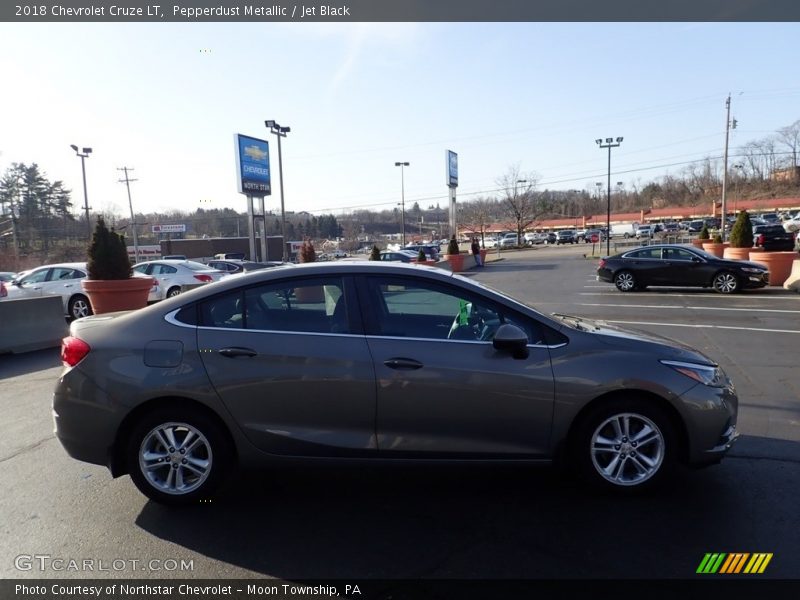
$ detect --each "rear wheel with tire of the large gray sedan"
[126,407,233,506]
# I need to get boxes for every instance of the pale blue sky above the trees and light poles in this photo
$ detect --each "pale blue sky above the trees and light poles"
[0,23,800,221]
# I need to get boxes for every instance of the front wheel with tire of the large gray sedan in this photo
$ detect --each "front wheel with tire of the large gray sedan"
[570,398,679,493]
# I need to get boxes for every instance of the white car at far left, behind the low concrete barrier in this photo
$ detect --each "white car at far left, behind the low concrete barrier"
[1,263,92,319]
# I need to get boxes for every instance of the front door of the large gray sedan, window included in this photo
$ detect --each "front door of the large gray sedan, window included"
[358,275,554,458]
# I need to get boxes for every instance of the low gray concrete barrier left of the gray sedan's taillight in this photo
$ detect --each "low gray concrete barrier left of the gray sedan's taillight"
[0,296,68,354]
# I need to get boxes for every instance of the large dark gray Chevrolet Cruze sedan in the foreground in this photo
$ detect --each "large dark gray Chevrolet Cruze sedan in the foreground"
[53,262,738,504]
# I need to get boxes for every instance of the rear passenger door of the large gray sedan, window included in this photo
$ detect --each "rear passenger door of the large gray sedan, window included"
[197,277,377,456]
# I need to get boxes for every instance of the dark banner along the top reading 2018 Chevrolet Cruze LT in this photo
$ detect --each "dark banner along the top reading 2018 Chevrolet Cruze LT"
[0,0,800,23]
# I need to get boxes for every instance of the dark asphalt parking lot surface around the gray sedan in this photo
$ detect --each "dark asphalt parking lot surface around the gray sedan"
[0,246,800,579]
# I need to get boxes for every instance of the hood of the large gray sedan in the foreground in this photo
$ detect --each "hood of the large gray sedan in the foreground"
[557,315,717,366]
